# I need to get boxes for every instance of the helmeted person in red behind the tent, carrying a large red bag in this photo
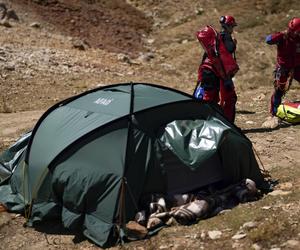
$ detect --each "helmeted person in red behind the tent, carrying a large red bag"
[194,16,237,123]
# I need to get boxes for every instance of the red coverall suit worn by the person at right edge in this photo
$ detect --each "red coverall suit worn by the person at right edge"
[266,32,300,116]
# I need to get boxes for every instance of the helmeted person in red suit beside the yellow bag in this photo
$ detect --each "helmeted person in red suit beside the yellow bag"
[263,17,300,128]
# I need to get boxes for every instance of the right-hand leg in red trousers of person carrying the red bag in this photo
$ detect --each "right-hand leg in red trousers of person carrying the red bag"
[220,80,237,123]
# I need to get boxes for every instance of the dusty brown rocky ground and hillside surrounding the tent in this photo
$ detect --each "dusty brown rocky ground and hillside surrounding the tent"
[0,0,300,249]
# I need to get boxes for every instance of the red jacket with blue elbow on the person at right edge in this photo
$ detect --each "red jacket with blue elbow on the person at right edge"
[266,32,300,69]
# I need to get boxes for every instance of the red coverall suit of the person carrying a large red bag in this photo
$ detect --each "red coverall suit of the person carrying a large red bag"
[198,31,237,122]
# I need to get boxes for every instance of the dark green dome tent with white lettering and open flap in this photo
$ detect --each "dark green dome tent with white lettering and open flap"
[0,83,263,247]
